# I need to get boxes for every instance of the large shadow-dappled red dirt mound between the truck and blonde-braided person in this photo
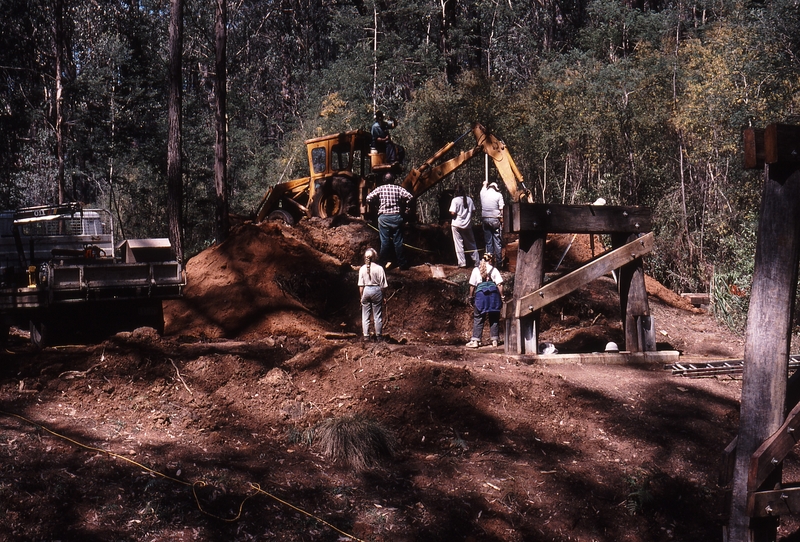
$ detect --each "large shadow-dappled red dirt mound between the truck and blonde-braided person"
[164,222,350,339]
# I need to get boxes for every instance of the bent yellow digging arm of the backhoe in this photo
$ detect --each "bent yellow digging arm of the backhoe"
[402,122,533,202]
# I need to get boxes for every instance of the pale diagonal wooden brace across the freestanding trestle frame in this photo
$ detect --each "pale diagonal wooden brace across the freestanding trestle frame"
[511,232,654,318]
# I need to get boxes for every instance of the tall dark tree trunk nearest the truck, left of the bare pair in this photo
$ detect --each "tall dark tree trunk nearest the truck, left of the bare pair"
[167,0,183,261]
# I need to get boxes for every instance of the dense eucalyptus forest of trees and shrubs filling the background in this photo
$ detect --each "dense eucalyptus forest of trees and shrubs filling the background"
[0,0,800,332]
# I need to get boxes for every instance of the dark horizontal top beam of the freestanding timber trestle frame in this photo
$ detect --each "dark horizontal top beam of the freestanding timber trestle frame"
[504,202,653,233]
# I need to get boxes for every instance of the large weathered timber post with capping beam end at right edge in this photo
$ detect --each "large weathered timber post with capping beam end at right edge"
[725,124,800,542]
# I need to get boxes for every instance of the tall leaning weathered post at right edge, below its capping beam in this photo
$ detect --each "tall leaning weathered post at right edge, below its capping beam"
[726,160,800,542]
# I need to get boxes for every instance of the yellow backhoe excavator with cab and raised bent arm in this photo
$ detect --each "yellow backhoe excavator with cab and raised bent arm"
[256,123,533,225]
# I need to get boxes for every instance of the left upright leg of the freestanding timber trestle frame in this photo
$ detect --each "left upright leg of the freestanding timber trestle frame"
[504,230,547,354]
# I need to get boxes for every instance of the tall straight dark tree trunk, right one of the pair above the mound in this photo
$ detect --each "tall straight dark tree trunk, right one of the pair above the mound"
[214,0,230,243]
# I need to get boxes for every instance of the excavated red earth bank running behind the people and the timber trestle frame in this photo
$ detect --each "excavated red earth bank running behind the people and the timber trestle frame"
[164,222,712,352]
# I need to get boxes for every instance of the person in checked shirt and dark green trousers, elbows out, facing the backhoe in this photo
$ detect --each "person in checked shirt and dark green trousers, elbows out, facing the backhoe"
[367,173,414,269]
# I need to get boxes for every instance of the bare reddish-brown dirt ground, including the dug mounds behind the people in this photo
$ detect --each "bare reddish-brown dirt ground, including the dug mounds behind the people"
[0,221,798,542]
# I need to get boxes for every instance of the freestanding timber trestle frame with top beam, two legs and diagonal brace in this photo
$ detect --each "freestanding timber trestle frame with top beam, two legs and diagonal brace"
[501,202,656,355]
